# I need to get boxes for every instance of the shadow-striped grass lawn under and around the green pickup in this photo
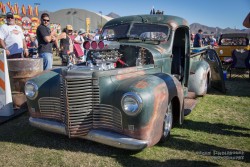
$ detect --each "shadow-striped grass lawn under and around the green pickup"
[0,79,250,167]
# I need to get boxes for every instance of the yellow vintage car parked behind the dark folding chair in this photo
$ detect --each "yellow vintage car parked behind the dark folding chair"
[215,33,250,62]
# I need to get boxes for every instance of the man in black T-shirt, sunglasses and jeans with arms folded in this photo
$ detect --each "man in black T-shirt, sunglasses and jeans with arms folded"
[36,13,56,70]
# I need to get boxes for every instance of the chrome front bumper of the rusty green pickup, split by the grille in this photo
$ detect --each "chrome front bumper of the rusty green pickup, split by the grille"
[29,117,148,150]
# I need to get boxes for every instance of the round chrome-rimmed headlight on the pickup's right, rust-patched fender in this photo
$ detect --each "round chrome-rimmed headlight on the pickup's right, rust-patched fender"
[121,92,142,116]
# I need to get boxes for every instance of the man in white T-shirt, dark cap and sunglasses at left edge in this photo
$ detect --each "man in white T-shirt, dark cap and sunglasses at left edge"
[0,12,29,59]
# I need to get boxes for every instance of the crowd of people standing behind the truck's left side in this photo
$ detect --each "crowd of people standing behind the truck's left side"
[0,12,101,70]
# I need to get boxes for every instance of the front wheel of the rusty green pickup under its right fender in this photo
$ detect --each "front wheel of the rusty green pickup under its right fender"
[160,102,173,143]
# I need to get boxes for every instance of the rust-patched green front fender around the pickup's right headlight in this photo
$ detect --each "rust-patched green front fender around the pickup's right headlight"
[112,75,169,146]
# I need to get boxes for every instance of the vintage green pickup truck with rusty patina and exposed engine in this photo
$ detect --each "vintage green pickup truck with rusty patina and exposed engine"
[25,15,225,150]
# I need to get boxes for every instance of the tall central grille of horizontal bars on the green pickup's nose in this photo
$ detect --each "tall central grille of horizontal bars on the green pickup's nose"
[65,78,100,137]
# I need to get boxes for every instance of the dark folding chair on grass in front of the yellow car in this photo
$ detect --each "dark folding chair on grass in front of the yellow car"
[229,49,250,78]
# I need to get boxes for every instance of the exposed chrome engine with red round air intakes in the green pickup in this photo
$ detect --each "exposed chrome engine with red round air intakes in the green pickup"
[84,41,153,70]
